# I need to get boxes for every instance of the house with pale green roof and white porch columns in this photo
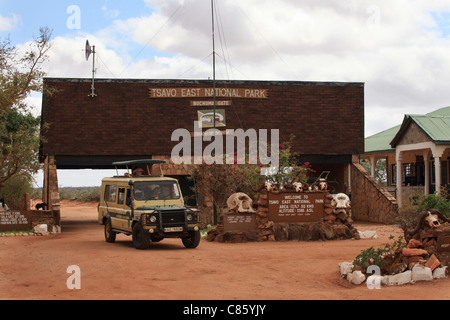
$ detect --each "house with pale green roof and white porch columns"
[361,107,450,207]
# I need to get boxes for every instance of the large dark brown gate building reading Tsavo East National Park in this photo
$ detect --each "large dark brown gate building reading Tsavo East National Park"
[40,78,364,218]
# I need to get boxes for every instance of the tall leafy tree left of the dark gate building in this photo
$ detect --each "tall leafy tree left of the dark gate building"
[0,28,51,189]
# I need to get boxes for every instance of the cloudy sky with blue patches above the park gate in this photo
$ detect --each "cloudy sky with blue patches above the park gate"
[0,0,450,186]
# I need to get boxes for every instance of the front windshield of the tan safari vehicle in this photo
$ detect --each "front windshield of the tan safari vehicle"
[134,181,180,201]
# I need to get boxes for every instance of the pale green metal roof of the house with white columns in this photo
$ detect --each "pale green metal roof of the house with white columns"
[364,107,450,154]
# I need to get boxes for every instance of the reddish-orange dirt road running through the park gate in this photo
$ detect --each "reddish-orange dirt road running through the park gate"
[0,203,450,300]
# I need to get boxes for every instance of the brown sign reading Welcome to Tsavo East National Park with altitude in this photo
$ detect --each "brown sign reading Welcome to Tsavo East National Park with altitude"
[269,192,326,222]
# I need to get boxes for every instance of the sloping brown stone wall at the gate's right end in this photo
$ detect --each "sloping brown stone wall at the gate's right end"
[351,163,398,223]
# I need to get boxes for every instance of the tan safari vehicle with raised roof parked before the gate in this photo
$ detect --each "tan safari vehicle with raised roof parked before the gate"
[98,159,200,249]
